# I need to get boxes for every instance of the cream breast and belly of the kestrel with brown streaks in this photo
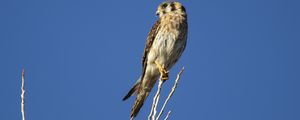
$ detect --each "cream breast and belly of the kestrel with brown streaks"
[148,20,186,69]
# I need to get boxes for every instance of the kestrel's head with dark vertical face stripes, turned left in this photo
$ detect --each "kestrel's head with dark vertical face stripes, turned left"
[156,2,186,17]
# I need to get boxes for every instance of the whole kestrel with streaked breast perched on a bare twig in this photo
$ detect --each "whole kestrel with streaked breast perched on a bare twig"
[123,2,188,118]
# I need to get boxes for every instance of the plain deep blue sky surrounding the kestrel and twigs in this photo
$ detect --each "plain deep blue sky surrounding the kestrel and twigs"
[0,0,300,120]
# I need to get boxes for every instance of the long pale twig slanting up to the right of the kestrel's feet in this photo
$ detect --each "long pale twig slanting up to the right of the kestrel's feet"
[156,67,184,120]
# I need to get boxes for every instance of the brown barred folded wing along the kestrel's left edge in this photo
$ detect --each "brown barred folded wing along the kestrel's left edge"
[141,19,161,81]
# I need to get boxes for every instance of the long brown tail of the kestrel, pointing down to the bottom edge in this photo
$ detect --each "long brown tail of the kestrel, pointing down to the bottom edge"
[130,89,150,119]
